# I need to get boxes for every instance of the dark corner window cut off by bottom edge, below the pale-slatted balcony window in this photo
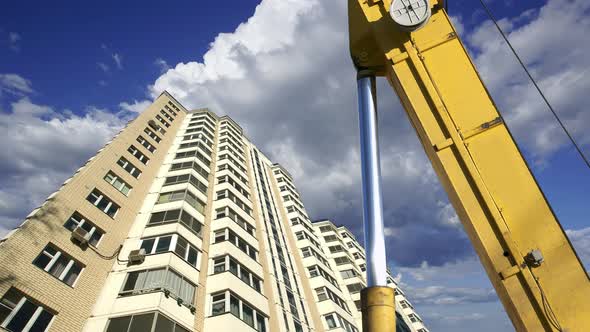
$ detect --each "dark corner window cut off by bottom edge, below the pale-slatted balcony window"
[106,312,191,332]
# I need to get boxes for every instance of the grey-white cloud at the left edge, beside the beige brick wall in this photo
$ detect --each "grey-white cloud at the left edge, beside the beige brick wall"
[0,97,127,232]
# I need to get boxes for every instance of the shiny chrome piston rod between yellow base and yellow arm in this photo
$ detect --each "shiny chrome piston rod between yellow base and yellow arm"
[357,71,387,287]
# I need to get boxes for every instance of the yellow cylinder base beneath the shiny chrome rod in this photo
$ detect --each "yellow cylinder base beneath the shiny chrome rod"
[361,287,395,332]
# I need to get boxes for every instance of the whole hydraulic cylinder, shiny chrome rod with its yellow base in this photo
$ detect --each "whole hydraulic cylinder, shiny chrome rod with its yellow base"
[357,71,395,332]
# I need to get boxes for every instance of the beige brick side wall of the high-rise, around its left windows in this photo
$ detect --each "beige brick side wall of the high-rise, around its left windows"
[0,93,184,332]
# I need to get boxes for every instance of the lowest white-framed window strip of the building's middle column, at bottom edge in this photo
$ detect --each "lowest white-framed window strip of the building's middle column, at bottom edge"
[211,290,267,332]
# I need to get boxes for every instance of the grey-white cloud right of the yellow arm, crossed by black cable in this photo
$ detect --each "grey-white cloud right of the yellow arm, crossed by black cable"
[467,0,590,163]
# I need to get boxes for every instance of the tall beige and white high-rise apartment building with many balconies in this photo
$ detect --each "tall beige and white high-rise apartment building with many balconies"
[0,92,426,332]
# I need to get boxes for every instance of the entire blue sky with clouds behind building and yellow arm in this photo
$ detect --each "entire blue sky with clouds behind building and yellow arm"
[0,0,590,332]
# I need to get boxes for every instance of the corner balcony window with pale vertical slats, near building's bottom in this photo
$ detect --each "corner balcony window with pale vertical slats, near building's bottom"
[119,268,197,305]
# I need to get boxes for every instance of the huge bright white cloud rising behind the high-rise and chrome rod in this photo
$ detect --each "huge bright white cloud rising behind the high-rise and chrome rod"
[150,0,478,266]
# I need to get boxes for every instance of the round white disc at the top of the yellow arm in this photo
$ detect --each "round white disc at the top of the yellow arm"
[389,0,430,31]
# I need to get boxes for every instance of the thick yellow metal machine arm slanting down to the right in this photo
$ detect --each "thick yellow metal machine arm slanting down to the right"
[349,0,590,332]
